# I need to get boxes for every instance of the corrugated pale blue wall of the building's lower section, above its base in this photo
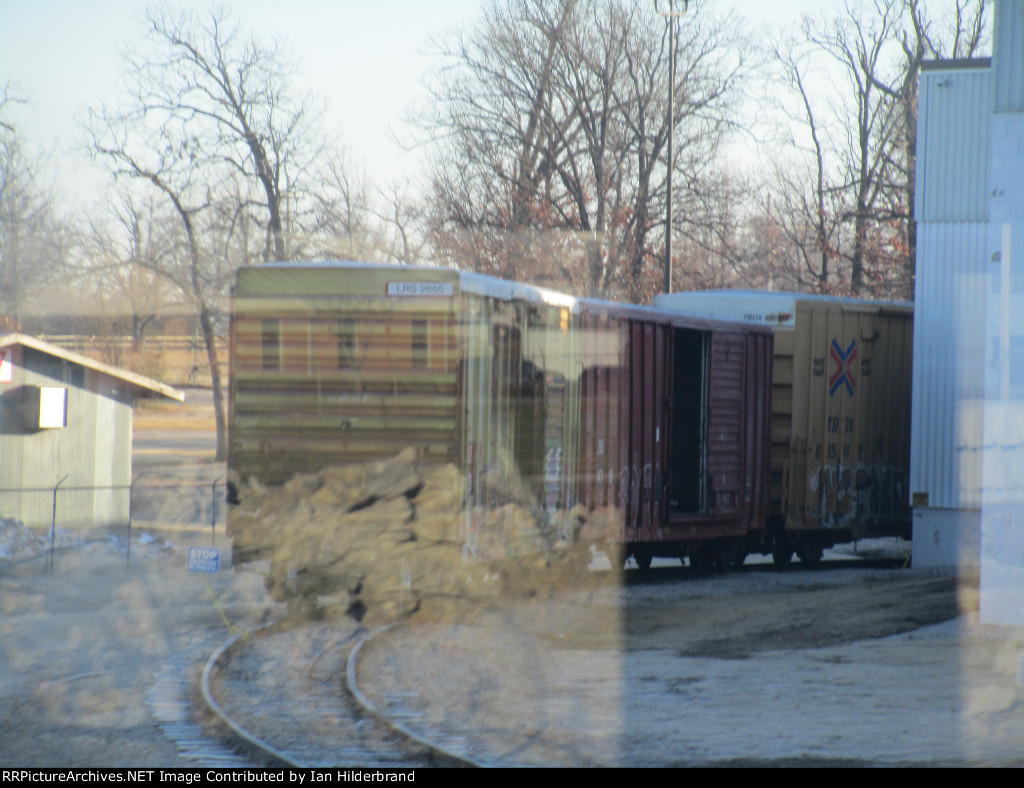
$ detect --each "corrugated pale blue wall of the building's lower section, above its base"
[910,56,992,509]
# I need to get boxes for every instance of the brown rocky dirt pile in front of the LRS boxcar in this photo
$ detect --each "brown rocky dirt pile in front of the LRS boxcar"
[228,449,590,624]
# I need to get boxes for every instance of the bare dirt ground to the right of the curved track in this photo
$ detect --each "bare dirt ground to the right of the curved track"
[360,568,1024,767]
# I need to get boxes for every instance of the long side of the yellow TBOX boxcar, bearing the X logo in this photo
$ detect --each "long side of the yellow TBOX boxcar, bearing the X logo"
[773,301,912,538]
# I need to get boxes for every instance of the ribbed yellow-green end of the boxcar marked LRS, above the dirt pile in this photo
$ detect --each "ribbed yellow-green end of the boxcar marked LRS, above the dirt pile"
[228,267,458,483]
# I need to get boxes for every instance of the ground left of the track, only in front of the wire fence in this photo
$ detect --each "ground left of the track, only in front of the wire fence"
[0,532,272,768]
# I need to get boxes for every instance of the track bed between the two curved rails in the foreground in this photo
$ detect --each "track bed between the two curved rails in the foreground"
[197,621,475,769]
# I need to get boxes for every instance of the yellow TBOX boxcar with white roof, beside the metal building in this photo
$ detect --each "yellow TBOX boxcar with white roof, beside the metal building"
[654,291,913,564]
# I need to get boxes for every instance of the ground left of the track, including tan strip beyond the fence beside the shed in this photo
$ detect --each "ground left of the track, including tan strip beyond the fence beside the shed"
[0,388,283,768]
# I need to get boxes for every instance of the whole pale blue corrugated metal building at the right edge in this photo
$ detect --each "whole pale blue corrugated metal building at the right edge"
[910,0,1024,624]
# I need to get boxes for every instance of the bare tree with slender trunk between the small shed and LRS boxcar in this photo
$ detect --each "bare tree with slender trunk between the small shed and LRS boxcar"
[89,11,335,459]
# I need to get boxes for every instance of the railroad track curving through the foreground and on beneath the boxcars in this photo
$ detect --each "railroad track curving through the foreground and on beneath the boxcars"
[150,559,913,769]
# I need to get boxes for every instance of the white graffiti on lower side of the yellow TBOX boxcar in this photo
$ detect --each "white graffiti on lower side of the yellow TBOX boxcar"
[810,465,907,528]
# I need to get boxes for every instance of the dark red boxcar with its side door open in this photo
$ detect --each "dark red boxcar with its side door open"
[580,301,771,567]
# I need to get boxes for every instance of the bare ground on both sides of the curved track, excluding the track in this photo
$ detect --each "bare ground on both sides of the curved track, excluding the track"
[0,388,1024,767]
